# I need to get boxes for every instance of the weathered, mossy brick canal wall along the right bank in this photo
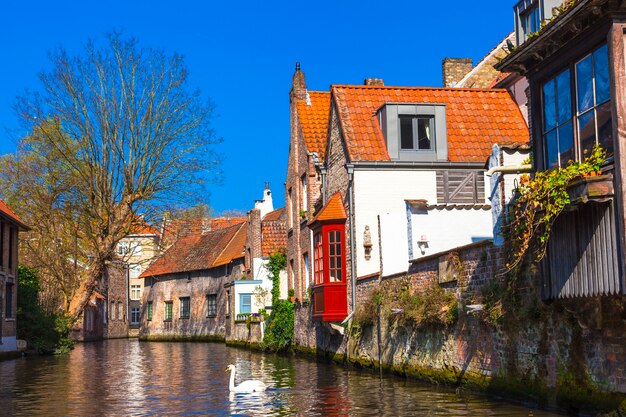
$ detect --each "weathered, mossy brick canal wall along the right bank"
[295,237,626,411]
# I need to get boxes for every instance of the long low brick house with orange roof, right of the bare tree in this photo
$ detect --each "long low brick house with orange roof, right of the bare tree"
[140,223,246,339]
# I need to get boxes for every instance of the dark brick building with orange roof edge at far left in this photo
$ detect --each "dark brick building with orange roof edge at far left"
[0,200,28,353]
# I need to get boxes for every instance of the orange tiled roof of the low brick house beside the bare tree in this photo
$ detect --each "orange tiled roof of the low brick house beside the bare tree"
[140,223,246,278]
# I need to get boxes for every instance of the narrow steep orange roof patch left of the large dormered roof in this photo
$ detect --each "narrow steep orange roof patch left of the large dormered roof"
[297,91,330,158]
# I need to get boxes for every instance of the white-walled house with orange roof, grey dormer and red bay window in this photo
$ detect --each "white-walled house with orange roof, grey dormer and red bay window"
[287,71,528,348]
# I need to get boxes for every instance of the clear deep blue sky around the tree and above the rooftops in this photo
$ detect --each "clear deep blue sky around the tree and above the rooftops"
[0,0,514,211]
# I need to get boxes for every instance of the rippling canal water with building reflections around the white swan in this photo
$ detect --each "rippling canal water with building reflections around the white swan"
[0,339,555,417]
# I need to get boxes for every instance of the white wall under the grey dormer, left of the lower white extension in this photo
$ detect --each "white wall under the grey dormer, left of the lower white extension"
[354,169,437,277]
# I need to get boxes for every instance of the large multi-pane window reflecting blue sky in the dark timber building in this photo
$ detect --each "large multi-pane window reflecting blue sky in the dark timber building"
[542,44,613,169]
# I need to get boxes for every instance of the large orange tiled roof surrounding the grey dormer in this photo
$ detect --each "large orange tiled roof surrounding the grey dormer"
[331,85,528,162]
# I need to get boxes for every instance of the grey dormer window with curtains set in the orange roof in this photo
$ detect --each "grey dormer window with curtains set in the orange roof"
[378,103,448,162]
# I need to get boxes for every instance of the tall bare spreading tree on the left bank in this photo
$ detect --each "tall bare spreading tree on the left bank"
[1,34,217,319]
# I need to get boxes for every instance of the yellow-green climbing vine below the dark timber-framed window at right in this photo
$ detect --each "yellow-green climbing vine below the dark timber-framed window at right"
[504,145,606,272]
